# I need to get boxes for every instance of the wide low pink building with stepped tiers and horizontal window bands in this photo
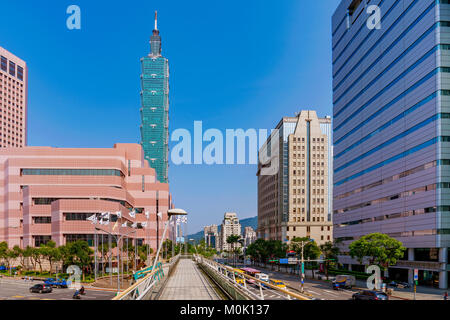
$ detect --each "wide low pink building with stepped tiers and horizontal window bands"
[0,144,171,248]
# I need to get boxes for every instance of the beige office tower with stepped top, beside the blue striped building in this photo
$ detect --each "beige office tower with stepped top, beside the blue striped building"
[257,111,333,244]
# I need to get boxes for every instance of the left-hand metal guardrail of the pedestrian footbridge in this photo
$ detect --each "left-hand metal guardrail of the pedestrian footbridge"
[112,256,180,300]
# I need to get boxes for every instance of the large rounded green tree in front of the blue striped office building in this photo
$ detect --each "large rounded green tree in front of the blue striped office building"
[349,233,406,270]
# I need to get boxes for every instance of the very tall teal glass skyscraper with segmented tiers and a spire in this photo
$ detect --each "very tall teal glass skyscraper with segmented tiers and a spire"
[141,13,169,183]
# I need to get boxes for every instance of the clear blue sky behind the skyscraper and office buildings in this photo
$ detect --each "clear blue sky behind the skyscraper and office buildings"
[0,0,339,232]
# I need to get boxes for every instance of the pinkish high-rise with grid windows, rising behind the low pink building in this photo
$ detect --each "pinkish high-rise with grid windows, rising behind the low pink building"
[0,47,28,148]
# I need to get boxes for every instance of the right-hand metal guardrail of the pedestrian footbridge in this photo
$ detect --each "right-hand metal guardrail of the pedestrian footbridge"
[194,255,311,300]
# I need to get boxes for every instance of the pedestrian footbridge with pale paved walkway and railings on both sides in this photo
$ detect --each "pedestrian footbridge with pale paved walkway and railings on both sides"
[113,255,309,300]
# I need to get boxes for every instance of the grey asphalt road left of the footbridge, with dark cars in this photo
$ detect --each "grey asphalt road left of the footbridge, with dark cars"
[0,278,115,300]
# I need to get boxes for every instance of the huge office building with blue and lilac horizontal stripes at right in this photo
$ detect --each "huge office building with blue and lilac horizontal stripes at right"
[332,0,450,288]
